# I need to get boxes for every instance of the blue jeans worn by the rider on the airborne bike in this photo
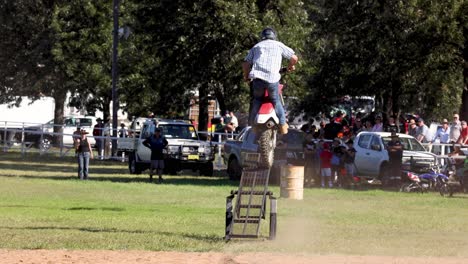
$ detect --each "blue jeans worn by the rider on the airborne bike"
[249,79,286,125]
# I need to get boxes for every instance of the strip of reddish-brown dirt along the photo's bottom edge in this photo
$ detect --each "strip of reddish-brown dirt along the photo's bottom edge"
[0,250,468,264]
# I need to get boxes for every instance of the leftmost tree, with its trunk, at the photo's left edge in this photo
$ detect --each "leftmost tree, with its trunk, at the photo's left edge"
[0,0,67,144]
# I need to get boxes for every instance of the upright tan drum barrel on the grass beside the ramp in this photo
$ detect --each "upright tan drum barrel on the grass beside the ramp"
[280,165,304,200]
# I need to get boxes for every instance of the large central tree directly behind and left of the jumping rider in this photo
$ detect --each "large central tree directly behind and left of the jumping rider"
[126,0,308,129]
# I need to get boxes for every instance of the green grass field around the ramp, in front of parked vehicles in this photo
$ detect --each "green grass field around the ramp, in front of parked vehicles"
[0,152,468,257]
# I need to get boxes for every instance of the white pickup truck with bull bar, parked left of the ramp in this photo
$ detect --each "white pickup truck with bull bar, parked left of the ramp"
[117,119,215,176]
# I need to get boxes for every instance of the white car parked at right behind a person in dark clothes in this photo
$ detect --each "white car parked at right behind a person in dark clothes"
[354,132,437,178]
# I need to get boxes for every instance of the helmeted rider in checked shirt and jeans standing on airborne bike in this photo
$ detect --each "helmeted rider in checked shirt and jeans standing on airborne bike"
[242,28,298,134]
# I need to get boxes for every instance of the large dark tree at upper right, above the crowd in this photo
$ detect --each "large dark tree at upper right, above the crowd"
[307,0,462,121]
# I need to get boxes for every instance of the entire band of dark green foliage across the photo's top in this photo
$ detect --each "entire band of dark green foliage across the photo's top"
[0,0,468,127]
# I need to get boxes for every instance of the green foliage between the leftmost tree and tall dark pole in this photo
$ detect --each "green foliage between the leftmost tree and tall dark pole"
[51,0,112,116]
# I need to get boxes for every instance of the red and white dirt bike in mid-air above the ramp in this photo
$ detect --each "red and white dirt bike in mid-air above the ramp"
[252,68,287,168]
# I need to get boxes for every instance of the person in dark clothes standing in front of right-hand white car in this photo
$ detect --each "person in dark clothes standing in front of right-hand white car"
[382,132,403,186]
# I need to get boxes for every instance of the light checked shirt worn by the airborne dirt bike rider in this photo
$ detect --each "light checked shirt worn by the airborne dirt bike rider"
[244,39,294,83]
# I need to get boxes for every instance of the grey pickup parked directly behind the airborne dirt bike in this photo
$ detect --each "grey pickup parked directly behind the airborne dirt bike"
[223,127,304,180]
